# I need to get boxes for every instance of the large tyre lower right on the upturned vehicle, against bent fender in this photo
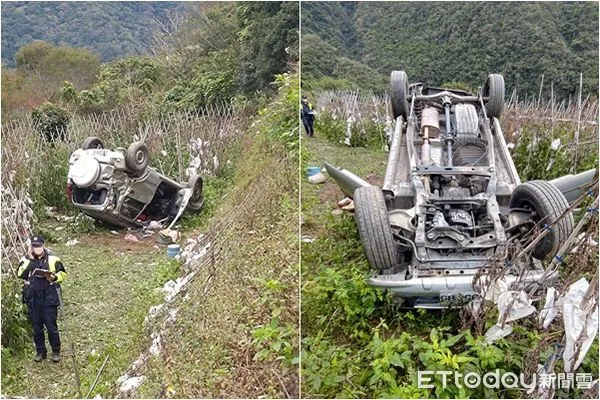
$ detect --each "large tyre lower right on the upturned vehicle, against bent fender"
[510,181,573,260]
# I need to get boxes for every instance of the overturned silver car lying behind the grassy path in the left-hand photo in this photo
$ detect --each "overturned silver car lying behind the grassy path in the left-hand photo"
[67,137,204,228]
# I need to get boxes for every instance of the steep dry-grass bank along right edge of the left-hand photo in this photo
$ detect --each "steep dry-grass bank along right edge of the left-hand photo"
[138,135,298,398]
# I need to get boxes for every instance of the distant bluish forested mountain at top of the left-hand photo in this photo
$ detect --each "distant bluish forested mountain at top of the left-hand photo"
[2,1,184,66]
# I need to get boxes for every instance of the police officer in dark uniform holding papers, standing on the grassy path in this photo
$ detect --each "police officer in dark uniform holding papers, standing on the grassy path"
[18,235,67,363]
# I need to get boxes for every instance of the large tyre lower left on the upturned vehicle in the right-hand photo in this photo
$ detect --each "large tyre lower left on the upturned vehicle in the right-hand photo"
[354,186,398,272]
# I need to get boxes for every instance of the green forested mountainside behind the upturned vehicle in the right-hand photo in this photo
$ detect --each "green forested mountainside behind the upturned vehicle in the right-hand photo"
[302,2,598,97]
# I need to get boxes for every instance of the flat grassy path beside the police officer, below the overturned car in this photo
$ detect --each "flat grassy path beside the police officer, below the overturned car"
[2,227,173,398]
